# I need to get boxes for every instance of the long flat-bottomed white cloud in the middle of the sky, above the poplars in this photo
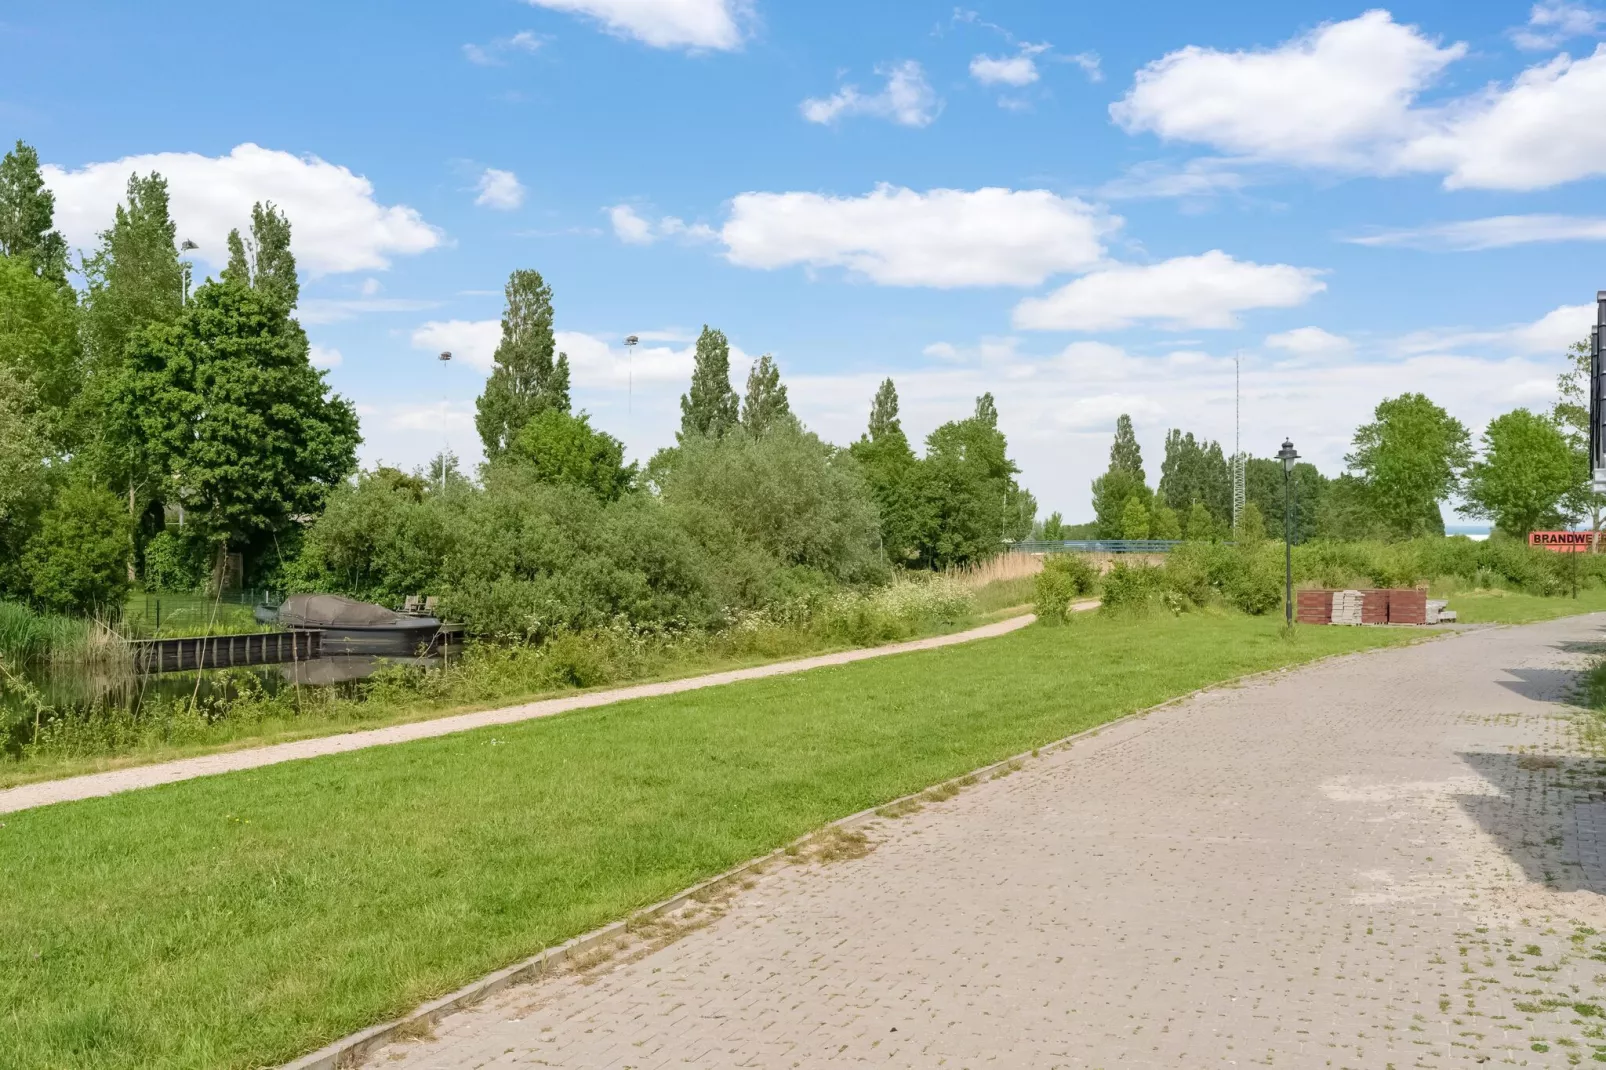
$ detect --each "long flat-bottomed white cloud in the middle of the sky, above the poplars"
[719,185,1121,288]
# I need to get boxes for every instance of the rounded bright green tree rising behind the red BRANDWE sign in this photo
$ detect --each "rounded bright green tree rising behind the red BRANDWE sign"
[1460,408,1577,538]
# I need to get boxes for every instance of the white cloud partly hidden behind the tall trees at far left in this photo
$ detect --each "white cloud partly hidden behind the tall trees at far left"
[42,143,445,276]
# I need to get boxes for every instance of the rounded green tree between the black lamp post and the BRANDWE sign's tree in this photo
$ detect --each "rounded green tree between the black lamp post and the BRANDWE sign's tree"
[1344,394,1471,538]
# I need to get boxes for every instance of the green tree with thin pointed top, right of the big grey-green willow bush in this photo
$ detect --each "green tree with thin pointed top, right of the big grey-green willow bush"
[919,394,1037,569]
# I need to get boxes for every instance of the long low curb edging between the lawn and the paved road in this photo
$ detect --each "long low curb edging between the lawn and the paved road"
[279,601,1478,1070]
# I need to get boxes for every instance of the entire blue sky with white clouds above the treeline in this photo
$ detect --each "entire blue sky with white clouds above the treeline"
[0,0,1606,519]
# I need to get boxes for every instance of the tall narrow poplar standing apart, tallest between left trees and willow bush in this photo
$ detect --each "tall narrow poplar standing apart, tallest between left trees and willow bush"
[474,272,570,461]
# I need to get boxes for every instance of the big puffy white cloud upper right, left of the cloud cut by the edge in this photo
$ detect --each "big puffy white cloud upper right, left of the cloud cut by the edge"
[1110,11,1466,167]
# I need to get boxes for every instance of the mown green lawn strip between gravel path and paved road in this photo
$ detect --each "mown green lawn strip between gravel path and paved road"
[0,614,1418,1068]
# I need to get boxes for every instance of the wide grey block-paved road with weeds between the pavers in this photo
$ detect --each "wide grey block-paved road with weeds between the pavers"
[368,615,1606,1070]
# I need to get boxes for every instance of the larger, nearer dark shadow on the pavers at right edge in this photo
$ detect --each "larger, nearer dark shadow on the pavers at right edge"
[1455,752,1606,893]
